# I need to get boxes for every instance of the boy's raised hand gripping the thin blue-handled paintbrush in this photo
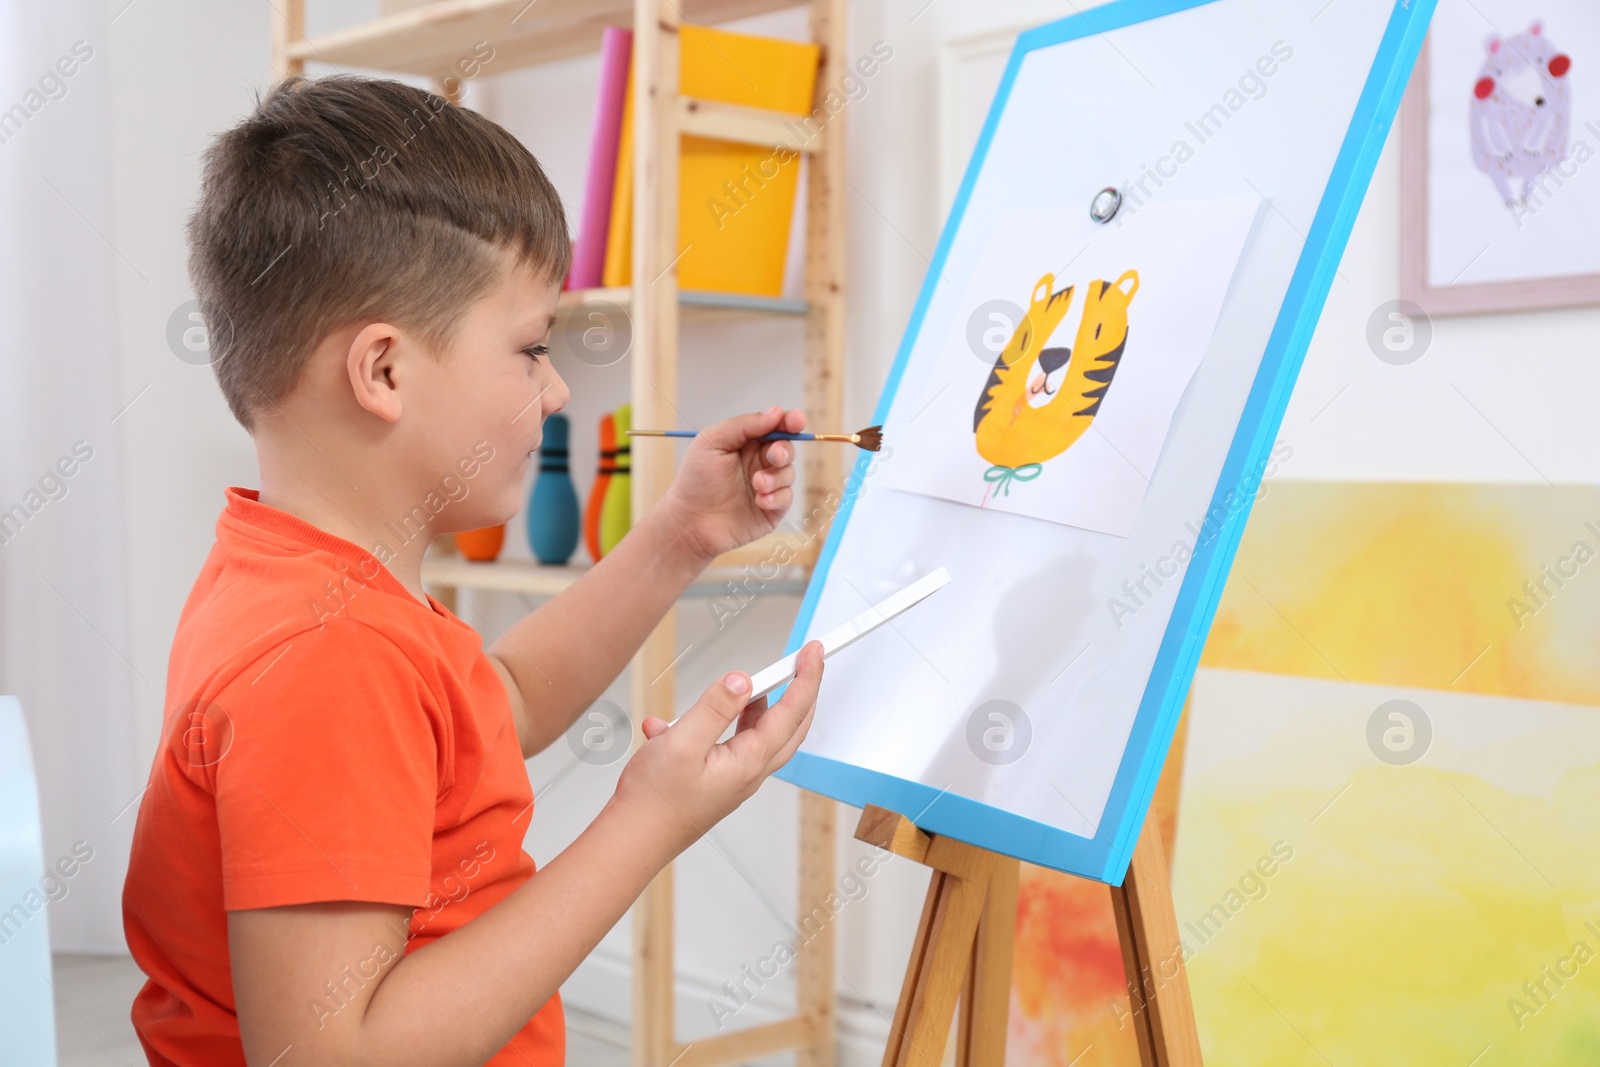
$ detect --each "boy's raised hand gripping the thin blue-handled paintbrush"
[662,405,805,563]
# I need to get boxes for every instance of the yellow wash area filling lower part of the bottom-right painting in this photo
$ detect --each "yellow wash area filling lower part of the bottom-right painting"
[1176,765,1600,1067]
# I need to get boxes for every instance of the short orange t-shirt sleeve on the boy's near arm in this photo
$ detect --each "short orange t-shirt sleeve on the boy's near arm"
[211,621,448,910]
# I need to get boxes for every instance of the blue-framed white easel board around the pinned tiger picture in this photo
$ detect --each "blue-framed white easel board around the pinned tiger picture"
[779,0,1434,885]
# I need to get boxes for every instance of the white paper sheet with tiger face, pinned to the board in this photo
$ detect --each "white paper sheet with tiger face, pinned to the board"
[888,197,1261,536]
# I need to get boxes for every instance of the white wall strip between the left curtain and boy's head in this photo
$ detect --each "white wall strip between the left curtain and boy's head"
[109,2,270,783]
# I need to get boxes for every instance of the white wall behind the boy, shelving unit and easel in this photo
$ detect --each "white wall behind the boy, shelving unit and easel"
[93,0,1600,1062]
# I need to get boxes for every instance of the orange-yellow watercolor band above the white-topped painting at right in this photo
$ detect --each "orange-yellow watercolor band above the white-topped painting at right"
[1200,482,1600,704]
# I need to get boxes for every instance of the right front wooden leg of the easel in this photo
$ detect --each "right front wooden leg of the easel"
[1110,814,1200,1067]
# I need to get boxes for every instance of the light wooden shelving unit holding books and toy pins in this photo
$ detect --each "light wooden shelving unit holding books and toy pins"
[272,0,853,1067]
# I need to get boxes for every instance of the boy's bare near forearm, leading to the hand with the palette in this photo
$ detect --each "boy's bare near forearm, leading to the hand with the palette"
[358,801,672,1065]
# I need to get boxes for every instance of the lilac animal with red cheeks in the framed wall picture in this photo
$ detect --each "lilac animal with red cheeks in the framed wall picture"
[1470,21,1573,206]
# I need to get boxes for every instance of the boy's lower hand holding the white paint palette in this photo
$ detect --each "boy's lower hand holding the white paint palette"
[614,641,822,859]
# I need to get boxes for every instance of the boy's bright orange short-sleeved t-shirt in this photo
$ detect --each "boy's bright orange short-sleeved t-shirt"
[122,488,566,1067]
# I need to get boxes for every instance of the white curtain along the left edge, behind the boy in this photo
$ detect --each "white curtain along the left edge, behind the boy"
[0,0,144,953]
